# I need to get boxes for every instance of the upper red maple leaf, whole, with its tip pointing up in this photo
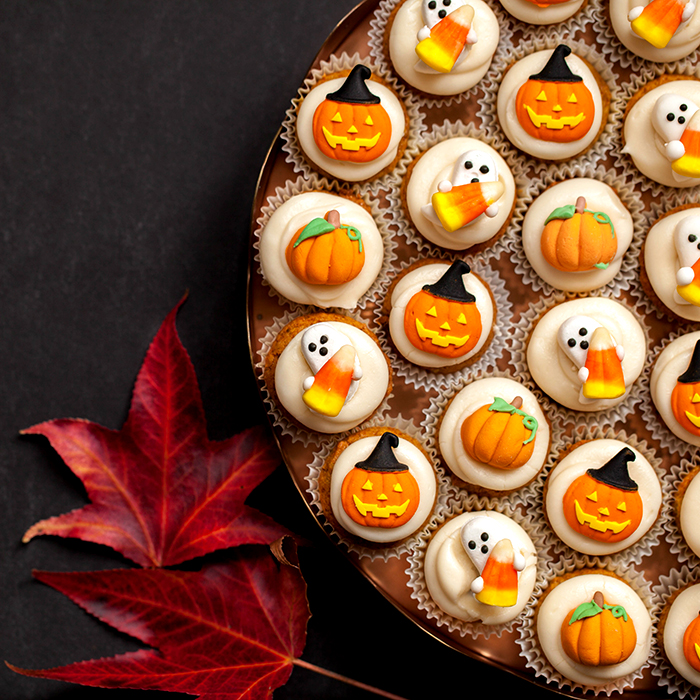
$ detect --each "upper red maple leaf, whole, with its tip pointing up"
[23,301,288,567]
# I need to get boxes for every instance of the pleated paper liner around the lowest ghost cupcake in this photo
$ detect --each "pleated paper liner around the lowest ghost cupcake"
[406,494,552,639]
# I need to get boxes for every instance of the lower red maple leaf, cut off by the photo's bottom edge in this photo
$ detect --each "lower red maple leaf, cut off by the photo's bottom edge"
[8,547,309,700]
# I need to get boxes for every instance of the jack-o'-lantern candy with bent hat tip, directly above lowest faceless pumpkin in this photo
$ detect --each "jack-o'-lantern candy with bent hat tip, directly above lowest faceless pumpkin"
[562,447,644,542]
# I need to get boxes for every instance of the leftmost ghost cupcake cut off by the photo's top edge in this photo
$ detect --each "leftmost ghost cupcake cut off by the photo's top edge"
[384,0,499,96]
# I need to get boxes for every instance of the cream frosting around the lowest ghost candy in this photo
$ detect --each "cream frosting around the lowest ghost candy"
[424,511,537,625]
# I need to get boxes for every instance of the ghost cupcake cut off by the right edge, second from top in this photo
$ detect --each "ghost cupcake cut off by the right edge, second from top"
[622,75,700,187]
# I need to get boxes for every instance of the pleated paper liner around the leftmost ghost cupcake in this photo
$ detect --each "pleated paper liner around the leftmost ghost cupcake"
[254,310,393,447]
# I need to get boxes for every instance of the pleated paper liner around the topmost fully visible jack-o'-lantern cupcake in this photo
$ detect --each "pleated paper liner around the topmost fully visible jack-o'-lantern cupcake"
[478,37,619,179]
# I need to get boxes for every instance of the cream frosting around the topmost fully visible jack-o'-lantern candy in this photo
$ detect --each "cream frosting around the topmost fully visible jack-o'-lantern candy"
[496,49,603,160]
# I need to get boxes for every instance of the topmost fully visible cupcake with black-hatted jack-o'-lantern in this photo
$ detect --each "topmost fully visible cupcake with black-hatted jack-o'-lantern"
[496,44,610,161]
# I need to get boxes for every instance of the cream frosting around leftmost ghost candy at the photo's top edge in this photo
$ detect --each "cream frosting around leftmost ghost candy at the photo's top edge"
[389,0,499,95]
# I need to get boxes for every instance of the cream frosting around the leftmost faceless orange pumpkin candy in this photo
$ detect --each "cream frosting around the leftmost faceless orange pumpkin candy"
[259,192,384,309]
